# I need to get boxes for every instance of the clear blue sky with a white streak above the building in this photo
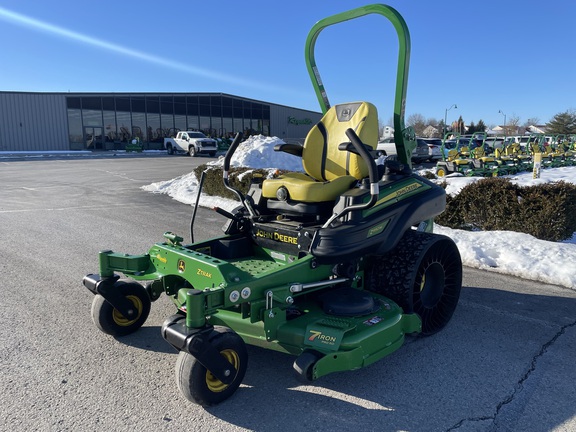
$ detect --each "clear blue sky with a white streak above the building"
[0,0,576,125]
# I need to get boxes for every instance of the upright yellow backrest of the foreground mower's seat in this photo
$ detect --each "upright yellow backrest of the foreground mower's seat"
[302,102,378,181]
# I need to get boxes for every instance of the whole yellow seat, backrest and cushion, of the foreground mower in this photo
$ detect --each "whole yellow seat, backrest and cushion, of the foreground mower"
[262,102,378,203]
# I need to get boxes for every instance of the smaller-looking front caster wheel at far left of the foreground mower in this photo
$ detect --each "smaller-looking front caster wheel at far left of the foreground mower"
[92,282,152,336]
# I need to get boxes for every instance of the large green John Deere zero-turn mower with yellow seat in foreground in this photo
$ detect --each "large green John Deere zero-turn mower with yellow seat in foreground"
[83,4,462,405]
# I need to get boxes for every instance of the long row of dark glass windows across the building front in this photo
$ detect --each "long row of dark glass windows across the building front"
[66,94,270,149]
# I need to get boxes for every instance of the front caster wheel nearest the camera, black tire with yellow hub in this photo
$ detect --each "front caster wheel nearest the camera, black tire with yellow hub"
[176,326,248,406]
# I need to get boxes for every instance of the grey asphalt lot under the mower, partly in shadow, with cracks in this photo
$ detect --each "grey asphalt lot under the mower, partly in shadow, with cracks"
[0,155,576,431]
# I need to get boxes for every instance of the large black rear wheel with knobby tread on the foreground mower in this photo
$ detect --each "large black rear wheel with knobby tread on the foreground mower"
[365,230,462,335]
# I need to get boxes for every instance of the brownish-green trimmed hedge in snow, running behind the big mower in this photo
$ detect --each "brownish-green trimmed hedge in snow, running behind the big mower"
[194,165,576,241]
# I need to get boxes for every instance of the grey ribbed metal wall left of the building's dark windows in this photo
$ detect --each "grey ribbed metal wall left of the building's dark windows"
[0,92,70,151]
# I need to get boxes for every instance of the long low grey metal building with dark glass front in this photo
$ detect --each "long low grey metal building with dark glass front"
[0,92,322,151]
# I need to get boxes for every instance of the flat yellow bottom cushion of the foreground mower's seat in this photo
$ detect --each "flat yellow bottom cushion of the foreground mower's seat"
[262,172,356,202]
